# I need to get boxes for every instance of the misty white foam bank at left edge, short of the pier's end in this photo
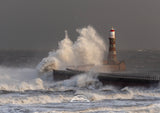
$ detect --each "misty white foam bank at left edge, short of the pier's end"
[0,66,44,91]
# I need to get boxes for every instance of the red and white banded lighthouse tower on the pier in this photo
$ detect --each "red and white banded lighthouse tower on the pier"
[108,27,119,64]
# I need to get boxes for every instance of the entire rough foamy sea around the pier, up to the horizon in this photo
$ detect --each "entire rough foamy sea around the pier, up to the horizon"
[0,50,160,113]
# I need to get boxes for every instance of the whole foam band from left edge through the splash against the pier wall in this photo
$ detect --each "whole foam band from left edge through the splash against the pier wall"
[0,67,101,91]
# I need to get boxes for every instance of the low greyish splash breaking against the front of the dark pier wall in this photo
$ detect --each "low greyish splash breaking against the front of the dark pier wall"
[50,72,102,91]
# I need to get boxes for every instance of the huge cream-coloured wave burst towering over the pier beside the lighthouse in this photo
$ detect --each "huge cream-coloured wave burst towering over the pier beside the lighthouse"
[37,26,106,72]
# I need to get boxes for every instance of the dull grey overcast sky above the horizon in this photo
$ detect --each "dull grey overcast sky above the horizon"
[0,0,160,50]
